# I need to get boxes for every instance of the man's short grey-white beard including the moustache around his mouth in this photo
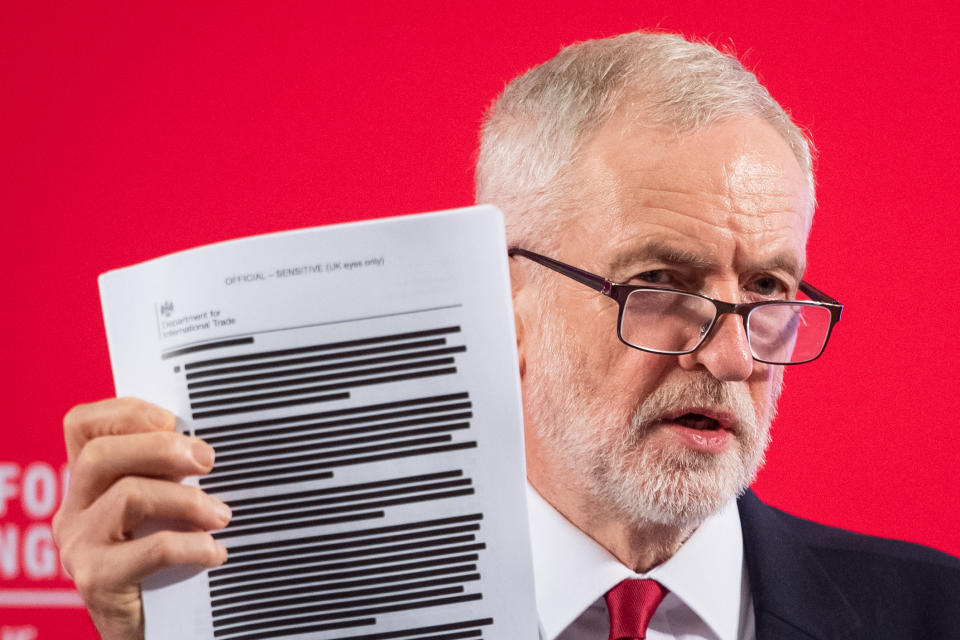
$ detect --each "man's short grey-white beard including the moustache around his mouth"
[527,322,782,527]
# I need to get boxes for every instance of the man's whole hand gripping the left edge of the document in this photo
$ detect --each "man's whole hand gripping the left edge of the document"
[53,398,230,640]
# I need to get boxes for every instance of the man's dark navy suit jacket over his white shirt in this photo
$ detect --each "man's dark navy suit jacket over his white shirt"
[738,491,960,640]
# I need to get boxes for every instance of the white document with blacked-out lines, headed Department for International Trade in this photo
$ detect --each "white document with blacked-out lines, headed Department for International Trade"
[100,207,537,640]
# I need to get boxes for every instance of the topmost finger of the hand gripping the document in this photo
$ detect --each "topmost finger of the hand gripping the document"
[63,398,176,463]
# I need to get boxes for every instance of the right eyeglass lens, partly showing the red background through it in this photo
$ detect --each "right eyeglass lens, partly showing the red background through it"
[747,303,830,364]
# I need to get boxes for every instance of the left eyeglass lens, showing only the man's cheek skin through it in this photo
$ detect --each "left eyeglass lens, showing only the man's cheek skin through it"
[620,290,716,353]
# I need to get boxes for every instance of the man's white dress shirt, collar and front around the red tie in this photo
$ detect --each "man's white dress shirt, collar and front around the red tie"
[527,485,755,640]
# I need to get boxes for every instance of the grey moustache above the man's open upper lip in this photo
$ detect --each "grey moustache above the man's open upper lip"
[632,373,757,436]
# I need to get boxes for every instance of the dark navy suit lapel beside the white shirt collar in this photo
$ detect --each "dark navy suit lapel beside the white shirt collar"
[737,491,860,640]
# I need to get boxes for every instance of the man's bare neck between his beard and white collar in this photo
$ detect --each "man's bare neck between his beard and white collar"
[529,478,700,573]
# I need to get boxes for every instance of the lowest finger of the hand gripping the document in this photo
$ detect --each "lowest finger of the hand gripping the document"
[73,531,227,600]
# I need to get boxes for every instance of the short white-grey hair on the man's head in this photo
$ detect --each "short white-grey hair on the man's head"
[476,31,815,250]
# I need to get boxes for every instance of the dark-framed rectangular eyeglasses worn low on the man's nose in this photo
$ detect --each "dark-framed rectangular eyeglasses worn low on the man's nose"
[507,247,843,364]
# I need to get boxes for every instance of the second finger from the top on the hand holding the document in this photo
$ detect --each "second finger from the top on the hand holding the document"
[64,431,214,511]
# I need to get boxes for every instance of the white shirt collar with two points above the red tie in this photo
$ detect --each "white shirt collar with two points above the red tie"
[527,484,750,640]
